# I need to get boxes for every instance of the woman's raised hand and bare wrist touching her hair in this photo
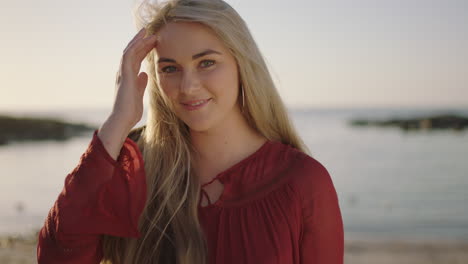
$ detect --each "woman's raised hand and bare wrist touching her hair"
[98,28,156,160]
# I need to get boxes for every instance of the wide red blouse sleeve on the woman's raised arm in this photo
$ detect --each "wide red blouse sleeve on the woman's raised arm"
[37,130,146,264]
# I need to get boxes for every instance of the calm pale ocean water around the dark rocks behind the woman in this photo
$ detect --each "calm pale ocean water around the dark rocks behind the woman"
[0,108,468,241]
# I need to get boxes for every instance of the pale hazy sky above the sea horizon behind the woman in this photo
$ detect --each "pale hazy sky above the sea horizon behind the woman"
[0,0,468,110]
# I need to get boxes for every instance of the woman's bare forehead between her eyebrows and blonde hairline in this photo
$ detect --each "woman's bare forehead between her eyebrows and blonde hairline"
[156,22,226,59]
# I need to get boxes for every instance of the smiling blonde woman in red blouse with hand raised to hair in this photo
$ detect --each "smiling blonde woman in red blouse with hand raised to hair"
[38,0,344,264]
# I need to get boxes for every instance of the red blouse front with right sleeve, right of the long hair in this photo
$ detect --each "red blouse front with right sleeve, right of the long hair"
[199,141,344,264]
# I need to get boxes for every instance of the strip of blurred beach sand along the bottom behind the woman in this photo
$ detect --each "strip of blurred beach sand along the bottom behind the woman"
[0,233,468,264]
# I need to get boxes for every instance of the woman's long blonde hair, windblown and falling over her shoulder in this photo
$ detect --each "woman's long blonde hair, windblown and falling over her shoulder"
[101,0,308,264]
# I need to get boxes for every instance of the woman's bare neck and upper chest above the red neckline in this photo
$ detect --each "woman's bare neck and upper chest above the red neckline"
[190,107,267,184]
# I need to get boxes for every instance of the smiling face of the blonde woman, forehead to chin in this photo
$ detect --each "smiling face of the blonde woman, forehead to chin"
[155,22,241,132]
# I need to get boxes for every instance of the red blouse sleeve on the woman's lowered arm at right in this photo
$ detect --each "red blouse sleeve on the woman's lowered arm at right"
[296,157,344,264]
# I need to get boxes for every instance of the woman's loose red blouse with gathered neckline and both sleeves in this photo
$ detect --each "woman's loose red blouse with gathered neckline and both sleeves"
[37,131,344,264]
